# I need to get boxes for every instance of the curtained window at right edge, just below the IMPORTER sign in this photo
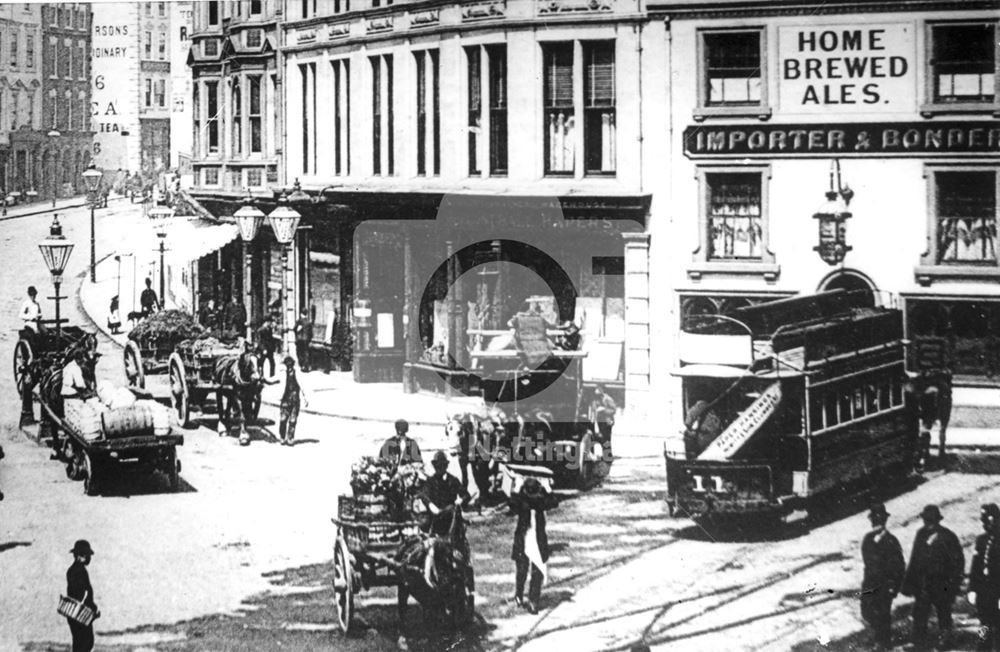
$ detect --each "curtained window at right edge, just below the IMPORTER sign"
[916,165,1000,285]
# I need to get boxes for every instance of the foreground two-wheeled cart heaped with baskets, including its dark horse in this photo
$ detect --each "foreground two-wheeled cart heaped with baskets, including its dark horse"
[332,457,474,634]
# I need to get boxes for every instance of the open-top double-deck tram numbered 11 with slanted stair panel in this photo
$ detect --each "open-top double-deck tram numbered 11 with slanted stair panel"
[666,291,925,518]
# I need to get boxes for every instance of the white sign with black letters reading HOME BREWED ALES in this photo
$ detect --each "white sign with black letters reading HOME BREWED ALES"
[778,23,917,114]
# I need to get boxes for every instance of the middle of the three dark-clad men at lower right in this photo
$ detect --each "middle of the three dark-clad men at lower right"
[902,505,965,646]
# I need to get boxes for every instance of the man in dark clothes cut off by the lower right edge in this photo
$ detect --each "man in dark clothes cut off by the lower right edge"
[968,503,1000,650]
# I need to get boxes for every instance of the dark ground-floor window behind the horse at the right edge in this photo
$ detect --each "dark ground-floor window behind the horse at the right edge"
[905,297,1000,384]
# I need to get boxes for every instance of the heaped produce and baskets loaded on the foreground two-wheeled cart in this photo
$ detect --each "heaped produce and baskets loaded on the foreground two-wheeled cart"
[338,457,426,522]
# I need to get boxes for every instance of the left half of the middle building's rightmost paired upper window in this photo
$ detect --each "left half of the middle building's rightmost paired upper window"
[542,42,576,175]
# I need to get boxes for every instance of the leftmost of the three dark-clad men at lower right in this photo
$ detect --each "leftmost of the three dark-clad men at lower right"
[861,503,906,649]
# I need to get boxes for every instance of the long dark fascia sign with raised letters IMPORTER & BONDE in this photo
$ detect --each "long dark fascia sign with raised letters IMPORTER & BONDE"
[684,121,1000,158]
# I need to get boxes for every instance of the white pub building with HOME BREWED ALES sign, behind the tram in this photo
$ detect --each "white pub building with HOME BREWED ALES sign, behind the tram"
[649,0,1000,451]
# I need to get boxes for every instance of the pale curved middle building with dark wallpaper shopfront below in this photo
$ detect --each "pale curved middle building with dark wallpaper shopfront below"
[191,0,668,414]
